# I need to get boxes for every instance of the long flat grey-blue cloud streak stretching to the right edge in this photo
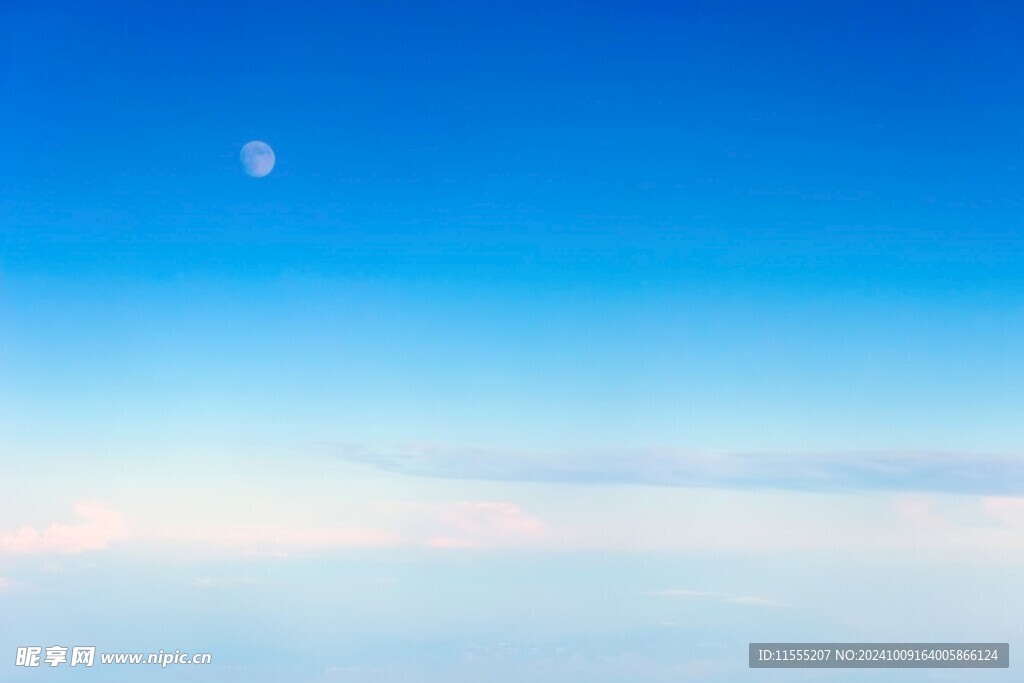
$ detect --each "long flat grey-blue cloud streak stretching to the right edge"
[335,444,1024,496]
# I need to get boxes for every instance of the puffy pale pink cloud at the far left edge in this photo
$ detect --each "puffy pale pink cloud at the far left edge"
[0,503,128,555]
